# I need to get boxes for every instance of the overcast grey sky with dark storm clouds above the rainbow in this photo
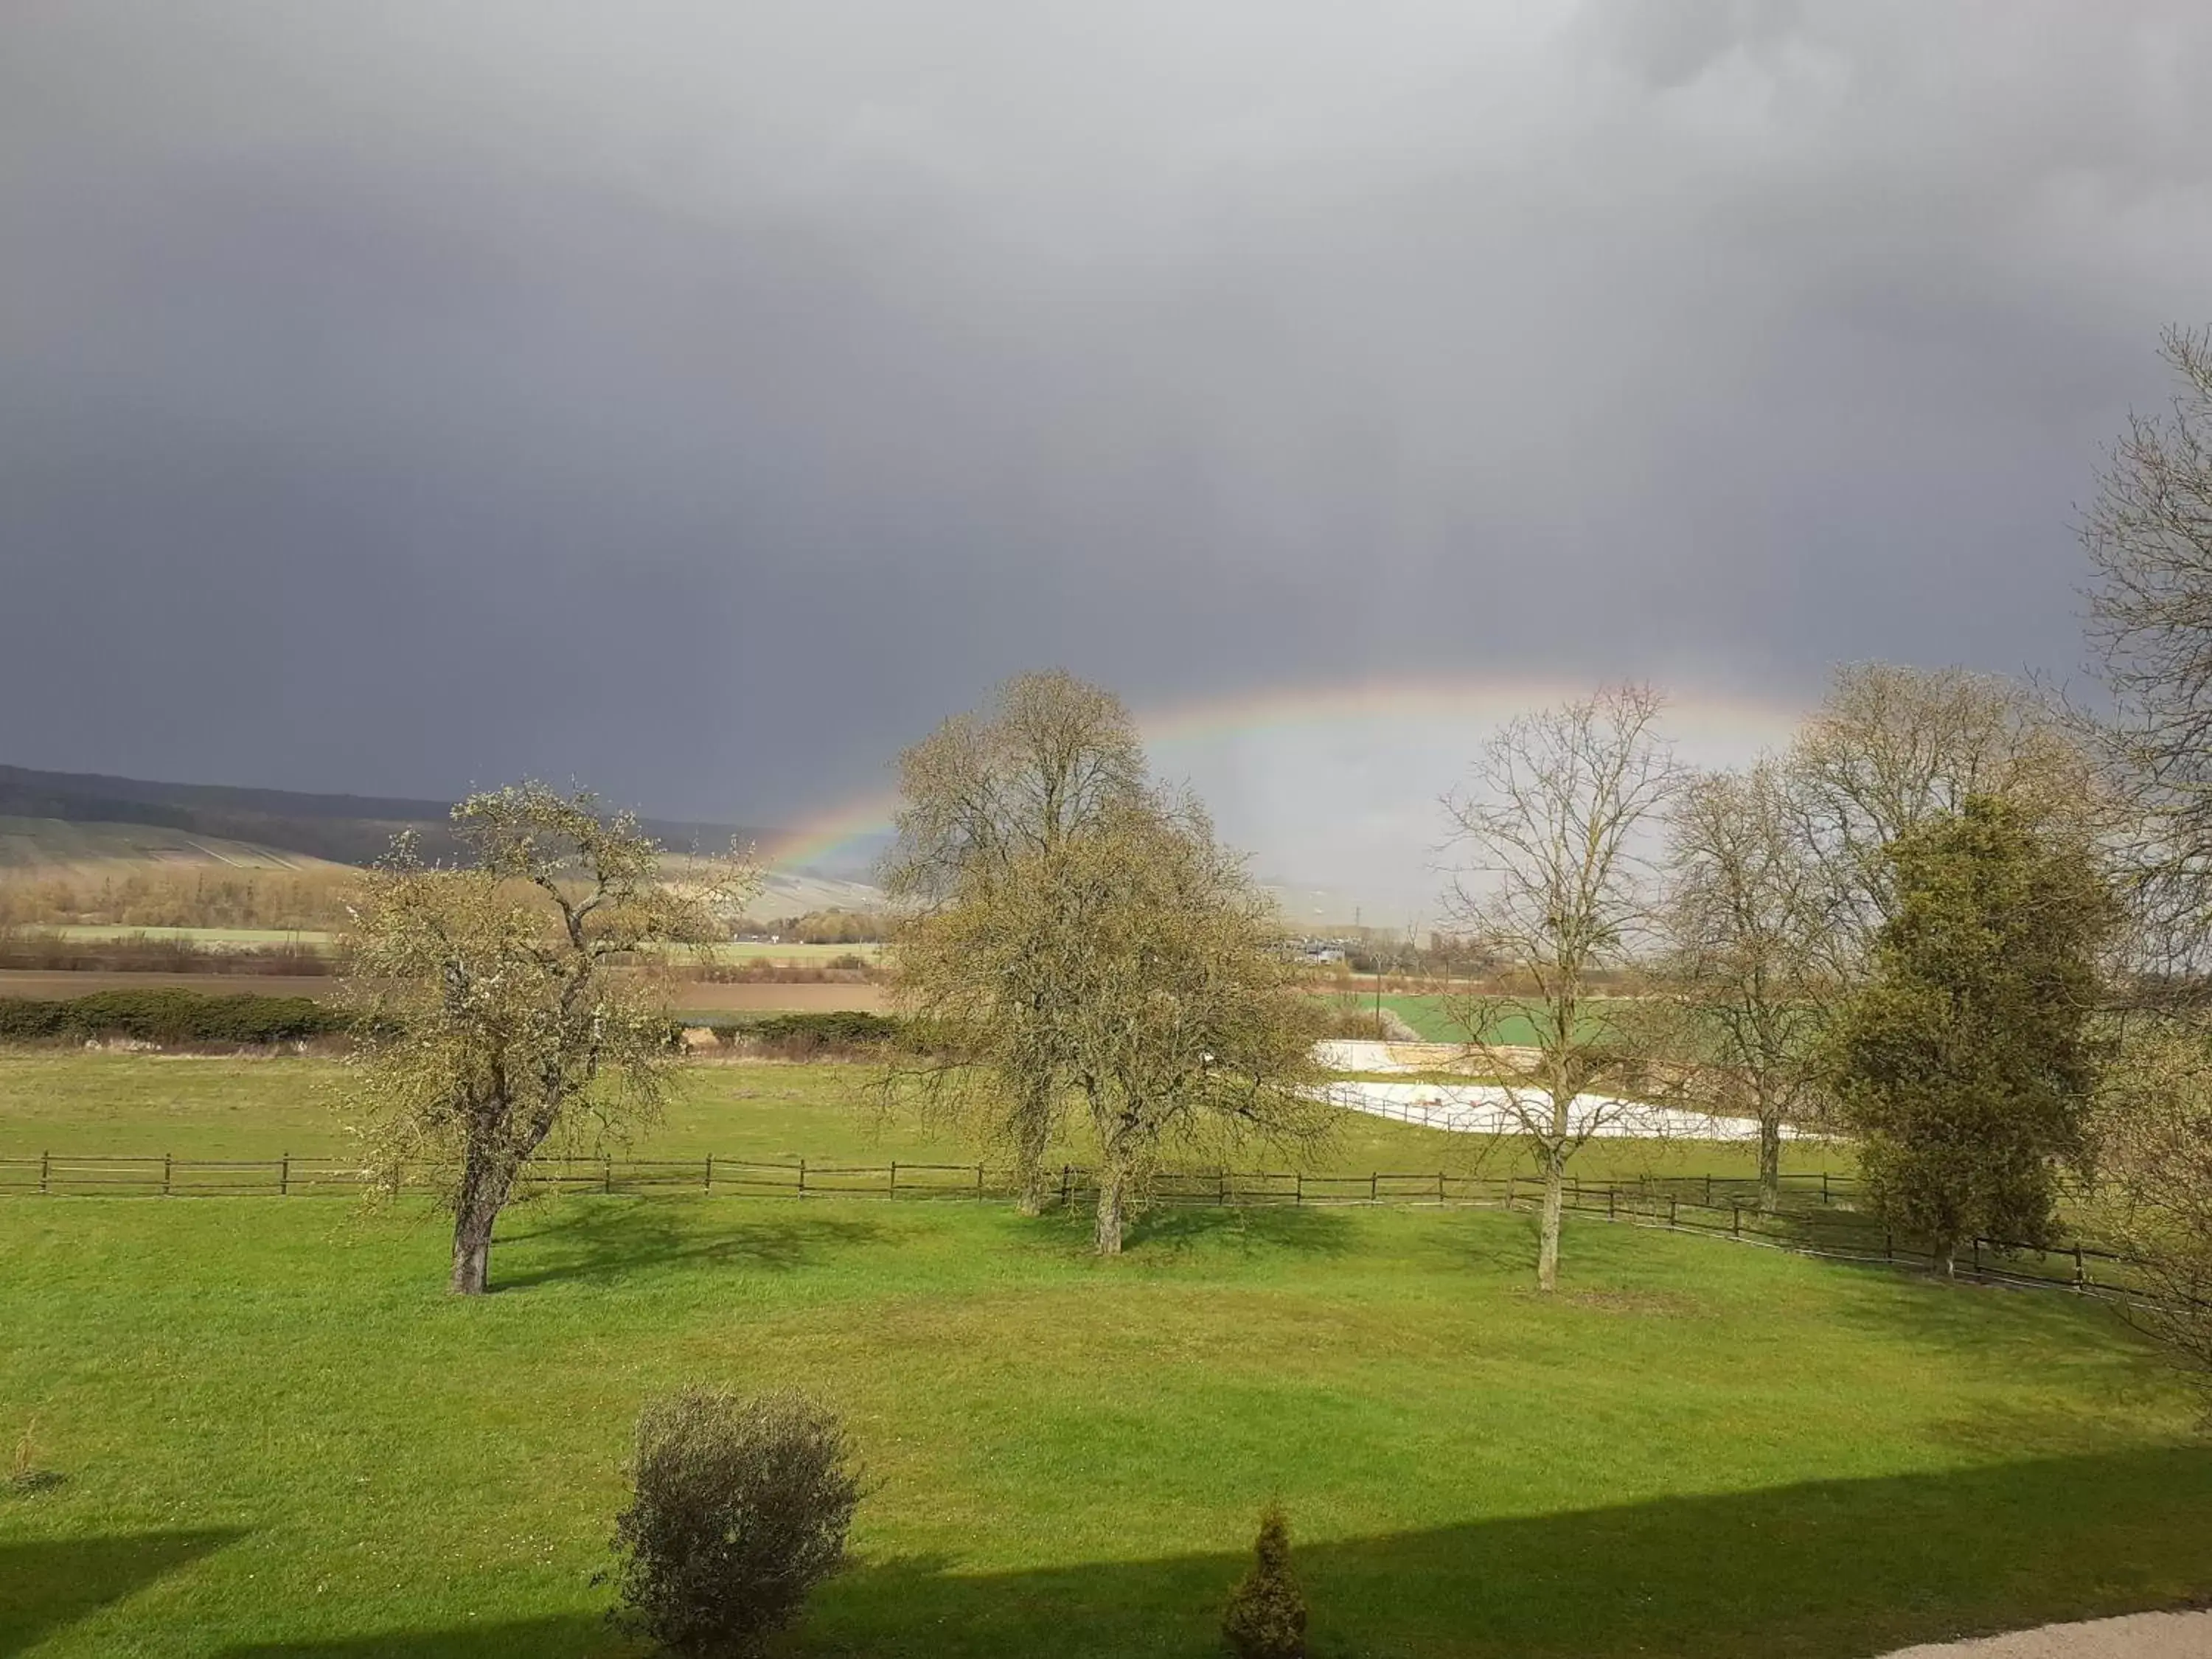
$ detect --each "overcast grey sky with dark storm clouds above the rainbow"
[0,0,2212,902]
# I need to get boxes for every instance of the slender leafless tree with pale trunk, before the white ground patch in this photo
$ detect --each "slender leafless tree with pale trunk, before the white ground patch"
[1444,686,1681,1290]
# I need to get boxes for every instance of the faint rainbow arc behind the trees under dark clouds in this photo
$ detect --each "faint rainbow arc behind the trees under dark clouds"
[763,677,1803,885]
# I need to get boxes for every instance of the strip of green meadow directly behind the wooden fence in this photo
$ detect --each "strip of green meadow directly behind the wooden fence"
[0,1048,1849,1181]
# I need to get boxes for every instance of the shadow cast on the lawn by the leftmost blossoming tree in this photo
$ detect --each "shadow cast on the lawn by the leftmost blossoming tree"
[491,1199,885,1290]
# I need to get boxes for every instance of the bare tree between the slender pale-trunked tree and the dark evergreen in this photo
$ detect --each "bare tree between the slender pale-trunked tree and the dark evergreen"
[1661,759,1832,1210]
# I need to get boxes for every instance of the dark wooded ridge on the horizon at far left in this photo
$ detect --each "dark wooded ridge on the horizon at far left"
[0,765,774,865]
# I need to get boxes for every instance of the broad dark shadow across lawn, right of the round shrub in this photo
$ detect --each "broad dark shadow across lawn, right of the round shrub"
[794,1447,2212,1659]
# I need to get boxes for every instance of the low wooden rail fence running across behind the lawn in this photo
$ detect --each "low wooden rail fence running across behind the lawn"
[0,1152,2148,1301]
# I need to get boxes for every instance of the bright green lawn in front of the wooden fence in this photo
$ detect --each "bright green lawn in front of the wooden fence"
[0,1199,2212,1659]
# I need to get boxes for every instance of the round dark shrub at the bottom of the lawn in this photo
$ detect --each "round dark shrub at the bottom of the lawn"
[615,1389,860,1657]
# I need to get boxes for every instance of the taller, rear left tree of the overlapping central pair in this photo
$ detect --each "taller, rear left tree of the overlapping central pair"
[883,670,1146,1214]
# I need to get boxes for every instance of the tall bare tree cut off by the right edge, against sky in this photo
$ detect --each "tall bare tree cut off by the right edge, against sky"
[2081,330,2212,978]
